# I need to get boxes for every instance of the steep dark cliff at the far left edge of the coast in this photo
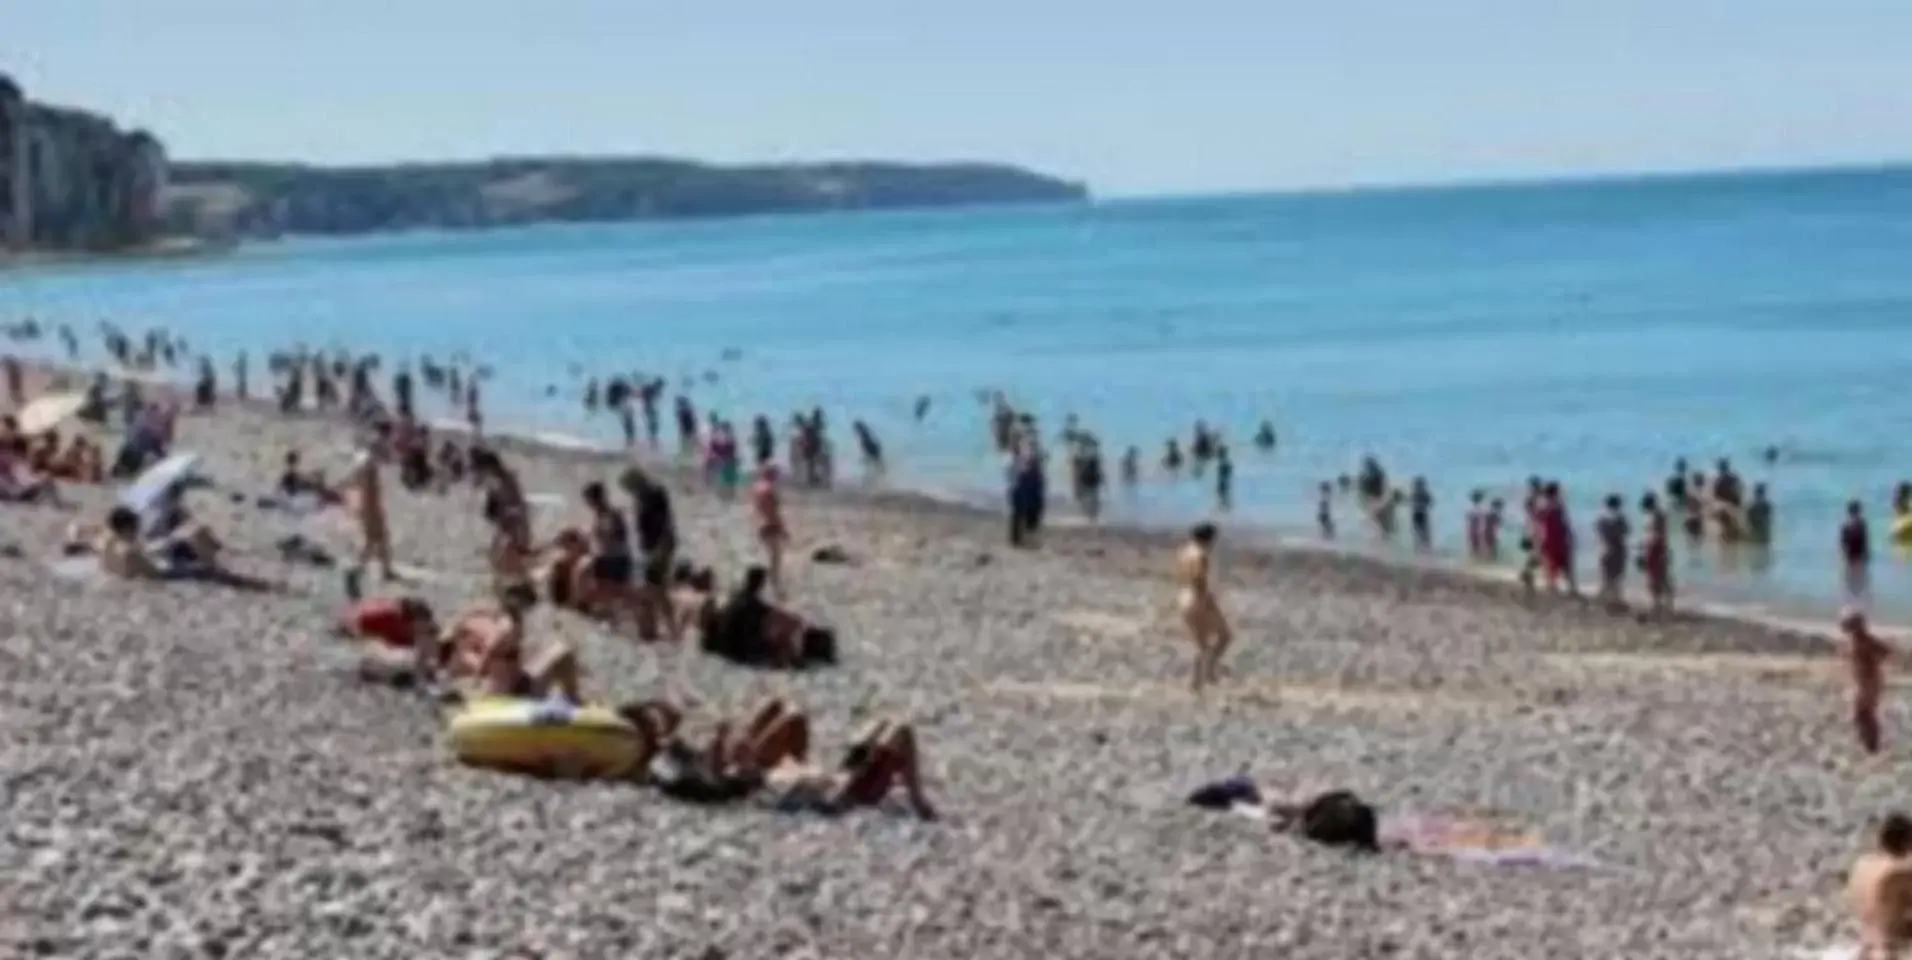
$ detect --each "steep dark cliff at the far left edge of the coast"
[0,75,166,252]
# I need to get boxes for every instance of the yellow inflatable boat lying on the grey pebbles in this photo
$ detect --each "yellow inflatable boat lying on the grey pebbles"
[449,698,642,778]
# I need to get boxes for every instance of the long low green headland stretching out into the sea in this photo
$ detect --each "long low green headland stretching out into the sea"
[164,157,1088,235]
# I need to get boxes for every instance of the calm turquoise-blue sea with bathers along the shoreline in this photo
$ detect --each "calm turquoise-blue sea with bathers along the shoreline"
[0,168,1912,616]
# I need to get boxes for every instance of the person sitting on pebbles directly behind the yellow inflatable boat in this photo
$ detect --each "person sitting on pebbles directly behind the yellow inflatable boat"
[440,583,583,704]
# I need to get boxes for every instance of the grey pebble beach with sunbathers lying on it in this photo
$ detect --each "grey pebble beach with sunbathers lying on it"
[0,392,1906,960]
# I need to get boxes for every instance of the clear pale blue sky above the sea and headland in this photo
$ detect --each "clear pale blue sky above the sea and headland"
[0,0,1912,193]
